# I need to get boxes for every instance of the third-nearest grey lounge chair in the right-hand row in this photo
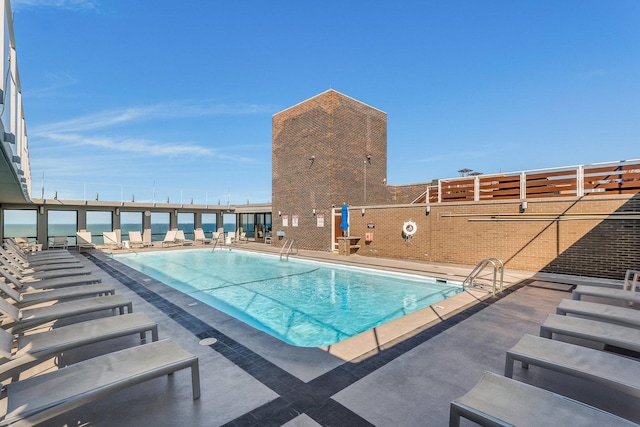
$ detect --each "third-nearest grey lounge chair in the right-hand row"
[540,314,640,352]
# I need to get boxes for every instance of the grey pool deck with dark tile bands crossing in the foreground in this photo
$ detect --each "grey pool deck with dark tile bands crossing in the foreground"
[1,243,640,427]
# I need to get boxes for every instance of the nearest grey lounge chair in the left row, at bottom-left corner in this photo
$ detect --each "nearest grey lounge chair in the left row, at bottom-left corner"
[1,340,200,425]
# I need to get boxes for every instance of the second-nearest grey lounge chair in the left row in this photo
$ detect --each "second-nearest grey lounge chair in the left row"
[0,313,158,381]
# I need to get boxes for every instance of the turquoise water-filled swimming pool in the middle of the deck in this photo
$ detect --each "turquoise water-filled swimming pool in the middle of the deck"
[114,249,462,347]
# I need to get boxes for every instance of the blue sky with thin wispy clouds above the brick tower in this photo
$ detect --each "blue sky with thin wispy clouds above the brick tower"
[12,0,640,204]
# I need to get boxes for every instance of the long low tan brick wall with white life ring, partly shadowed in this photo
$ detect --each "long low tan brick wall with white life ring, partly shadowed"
[350,196,640,279]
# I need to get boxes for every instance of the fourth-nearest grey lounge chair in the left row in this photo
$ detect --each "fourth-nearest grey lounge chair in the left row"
[0,280,116,308]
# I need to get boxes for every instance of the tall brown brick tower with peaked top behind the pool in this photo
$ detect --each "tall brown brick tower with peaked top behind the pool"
[272,90,388,250]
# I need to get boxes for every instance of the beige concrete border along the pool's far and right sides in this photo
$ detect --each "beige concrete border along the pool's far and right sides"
[103,245,535,362]
